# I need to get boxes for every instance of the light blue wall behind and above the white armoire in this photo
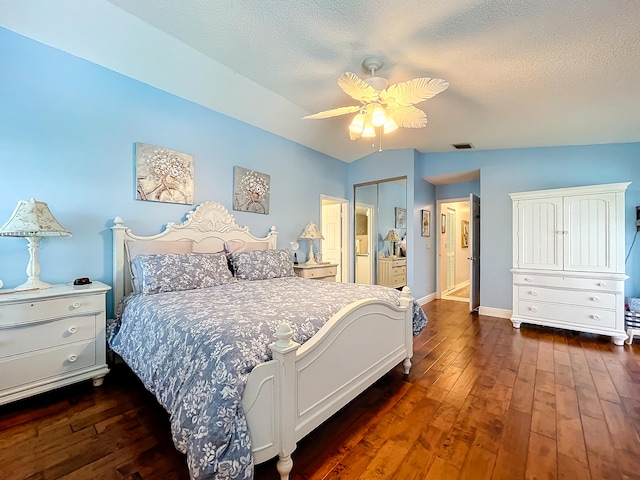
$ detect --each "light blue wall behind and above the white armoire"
[416,143,640,310]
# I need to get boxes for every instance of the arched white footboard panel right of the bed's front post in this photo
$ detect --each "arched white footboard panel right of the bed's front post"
[295,300,413,441]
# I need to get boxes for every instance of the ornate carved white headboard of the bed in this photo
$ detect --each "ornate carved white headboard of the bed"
[111,202,278,313]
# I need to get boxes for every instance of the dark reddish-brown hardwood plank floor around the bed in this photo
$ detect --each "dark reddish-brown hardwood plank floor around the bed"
[0,300,640,480]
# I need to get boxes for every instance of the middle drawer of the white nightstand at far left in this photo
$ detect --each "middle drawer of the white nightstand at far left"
[0,315,96,358]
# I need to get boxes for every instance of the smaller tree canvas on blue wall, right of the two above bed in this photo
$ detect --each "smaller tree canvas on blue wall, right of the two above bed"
[233,167,271,215]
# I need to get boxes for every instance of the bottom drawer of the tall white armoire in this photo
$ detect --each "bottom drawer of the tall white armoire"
[517,300,616,328]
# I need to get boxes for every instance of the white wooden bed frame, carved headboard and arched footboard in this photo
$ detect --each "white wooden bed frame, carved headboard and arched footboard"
[112,202,413,480]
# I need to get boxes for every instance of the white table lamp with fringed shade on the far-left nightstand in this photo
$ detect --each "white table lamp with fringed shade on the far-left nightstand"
[0,198,71,290]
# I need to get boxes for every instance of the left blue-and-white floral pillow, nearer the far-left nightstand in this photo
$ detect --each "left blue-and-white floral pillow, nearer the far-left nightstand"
[132,253,236,295]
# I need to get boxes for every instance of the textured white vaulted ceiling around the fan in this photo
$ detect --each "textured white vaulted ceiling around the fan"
[0,0,640,162]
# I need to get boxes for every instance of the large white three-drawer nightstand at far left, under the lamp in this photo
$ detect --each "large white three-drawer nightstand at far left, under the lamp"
[0,282,111,405]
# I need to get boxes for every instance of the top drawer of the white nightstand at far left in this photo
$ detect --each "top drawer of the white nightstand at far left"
[0,295,105,328]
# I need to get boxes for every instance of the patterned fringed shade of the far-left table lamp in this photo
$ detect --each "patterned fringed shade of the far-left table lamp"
[0,198,71,237]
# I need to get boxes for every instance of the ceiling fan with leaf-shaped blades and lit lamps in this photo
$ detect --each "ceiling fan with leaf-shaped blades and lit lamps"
[304,57,449,140]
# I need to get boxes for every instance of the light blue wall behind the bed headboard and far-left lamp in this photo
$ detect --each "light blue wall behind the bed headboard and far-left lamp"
[0,29,348,316]
